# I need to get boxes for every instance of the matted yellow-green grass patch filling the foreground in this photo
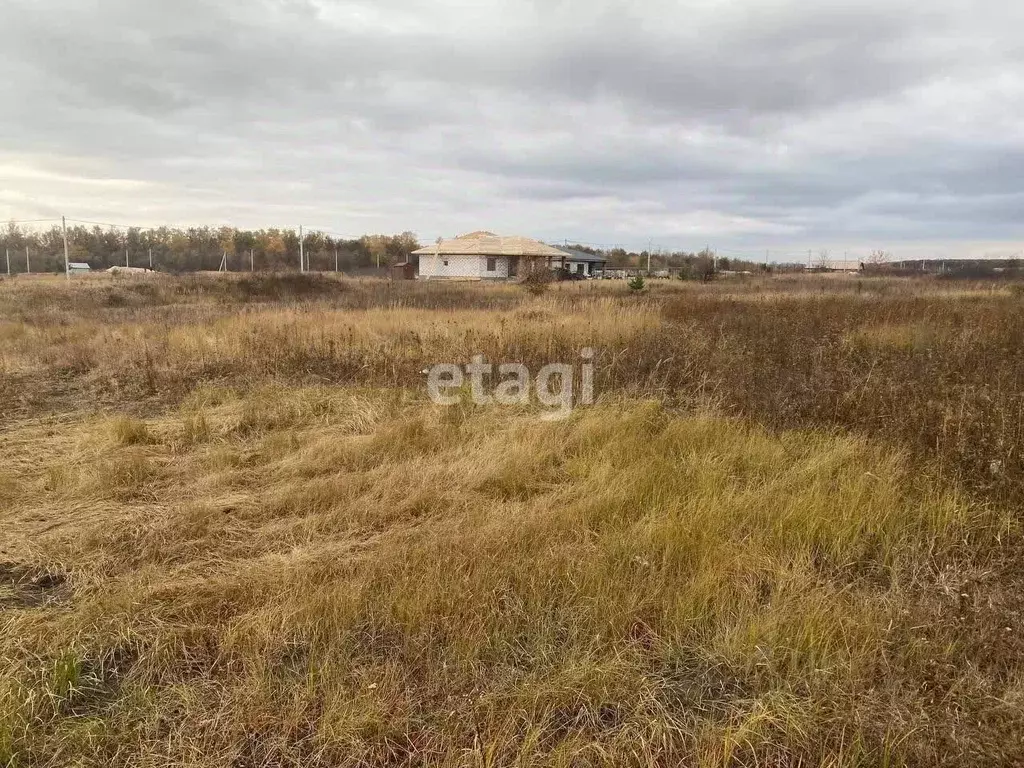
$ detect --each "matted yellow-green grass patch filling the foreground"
[0,388,1021,766]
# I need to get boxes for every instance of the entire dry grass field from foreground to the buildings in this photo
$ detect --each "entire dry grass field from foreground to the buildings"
[0,274,1024,768]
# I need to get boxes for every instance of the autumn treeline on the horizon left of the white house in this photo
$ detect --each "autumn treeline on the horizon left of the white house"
[0,223,419,272]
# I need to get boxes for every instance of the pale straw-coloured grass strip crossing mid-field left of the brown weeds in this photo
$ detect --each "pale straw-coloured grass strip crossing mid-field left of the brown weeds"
[0,288,660,379]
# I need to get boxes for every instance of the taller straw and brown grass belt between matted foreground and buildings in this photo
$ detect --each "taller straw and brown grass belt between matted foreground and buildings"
[0,275,1024,503]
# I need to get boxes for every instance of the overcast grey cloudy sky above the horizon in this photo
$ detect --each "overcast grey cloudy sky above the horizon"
[0,0,1024,259]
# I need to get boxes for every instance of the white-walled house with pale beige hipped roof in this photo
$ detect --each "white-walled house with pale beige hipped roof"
[413,231,567,280]
